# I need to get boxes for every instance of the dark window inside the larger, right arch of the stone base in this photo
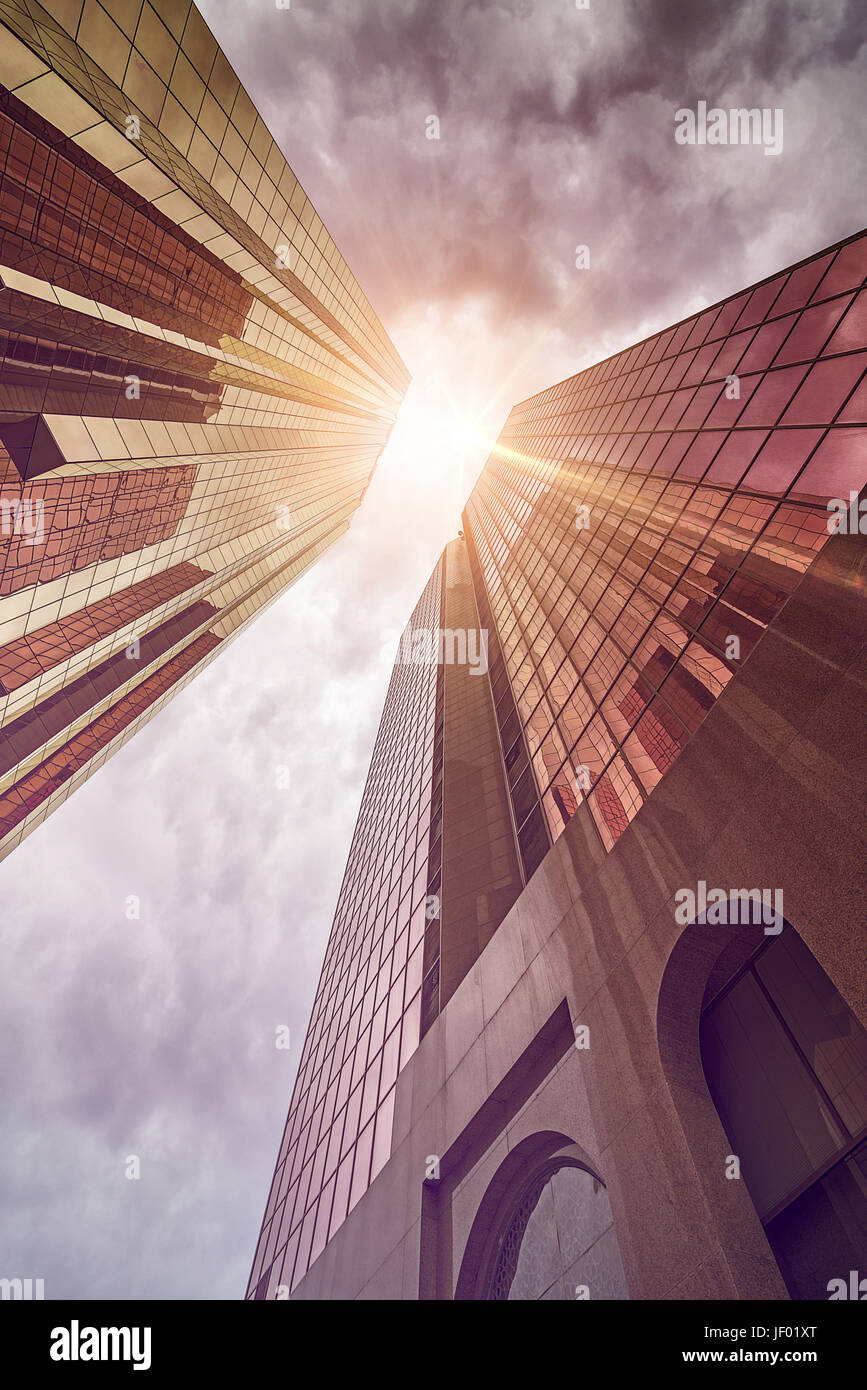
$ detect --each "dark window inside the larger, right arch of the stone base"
[700,926,867,1298]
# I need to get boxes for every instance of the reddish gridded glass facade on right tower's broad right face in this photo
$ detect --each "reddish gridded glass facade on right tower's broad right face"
[464,235,867,856]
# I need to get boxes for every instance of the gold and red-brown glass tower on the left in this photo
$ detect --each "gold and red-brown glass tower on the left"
[0,0,408,856]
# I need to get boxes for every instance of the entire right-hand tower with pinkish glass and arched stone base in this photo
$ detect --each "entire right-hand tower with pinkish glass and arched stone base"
[247,234,867,1300]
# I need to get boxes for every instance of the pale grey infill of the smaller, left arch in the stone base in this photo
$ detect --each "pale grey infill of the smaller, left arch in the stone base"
[485,1161,629,1301]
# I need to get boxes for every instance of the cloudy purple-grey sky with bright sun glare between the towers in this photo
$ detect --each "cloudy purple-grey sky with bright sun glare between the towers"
[0,0,867,1298]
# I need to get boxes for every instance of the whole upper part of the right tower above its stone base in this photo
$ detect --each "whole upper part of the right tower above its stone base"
[247,222,867,1298]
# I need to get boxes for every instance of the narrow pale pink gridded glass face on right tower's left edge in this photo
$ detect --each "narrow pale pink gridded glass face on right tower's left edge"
[250,562,443,1298]
